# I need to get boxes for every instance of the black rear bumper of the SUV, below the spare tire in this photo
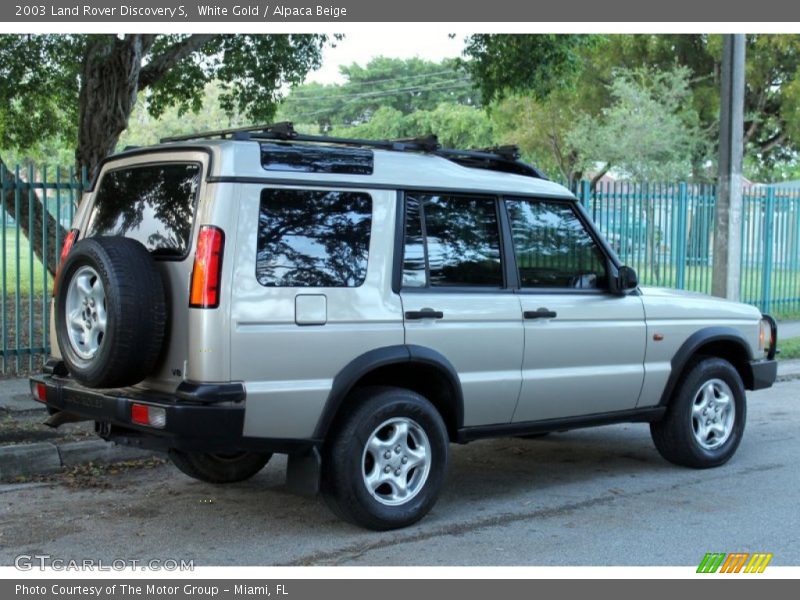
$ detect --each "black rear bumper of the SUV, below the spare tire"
[30,374,317,454]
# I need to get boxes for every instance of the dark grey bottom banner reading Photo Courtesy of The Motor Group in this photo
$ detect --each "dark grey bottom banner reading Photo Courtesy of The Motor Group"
[0,571,796,600]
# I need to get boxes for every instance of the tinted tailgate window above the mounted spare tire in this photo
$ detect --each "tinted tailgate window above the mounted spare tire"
[87,163,201,257]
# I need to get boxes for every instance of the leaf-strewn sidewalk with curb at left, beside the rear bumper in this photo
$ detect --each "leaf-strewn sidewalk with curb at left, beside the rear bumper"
[0,379,152,481]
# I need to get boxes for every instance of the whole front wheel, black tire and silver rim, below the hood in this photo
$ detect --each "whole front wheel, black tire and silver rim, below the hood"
[650,358,747,469]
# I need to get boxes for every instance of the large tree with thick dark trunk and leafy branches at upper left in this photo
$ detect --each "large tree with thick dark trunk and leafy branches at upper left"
[0,34,327,273]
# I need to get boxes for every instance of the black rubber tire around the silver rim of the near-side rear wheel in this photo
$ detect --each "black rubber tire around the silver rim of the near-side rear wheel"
[321,387,449,531]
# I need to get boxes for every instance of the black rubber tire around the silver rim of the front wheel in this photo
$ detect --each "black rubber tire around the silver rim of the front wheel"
[650,358,747,469]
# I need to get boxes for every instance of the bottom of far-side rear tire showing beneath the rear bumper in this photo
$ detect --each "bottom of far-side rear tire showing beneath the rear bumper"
[169,449,272,483]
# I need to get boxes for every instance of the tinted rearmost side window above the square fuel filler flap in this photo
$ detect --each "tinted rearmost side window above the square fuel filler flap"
[256,190,372,287]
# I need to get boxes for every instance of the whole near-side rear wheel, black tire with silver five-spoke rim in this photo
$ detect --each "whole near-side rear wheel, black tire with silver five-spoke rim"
[322,388,449,530]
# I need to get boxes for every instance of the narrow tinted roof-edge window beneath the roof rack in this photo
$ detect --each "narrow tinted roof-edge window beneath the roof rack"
[261,143,374,175]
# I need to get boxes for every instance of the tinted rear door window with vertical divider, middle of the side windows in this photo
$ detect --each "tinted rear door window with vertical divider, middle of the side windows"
[403,194,503,288]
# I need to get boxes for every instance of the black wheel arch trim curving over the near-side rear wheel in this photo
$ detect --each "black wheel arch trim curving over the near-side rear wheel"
[313,344,464,440]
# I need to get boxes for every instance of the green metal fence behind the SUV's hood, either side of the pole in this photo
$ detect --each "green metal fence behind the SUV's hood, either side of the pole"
[575,181,800,316]
